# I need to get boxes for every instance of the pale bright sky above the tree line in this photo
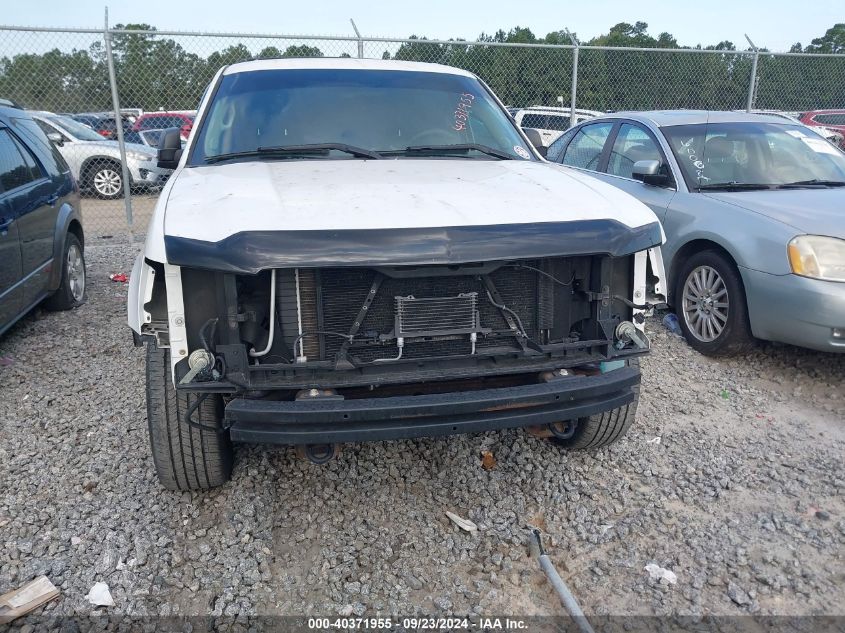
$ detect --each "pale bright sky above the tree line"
[0,0,845,51]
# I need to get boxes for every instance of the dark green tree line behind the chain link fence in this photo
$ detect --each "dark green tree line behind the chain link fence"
[0,22,845,112]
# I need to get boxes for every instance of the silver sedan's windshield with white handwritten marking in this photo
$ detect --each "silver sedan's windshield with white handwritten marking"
[662,123,845,190]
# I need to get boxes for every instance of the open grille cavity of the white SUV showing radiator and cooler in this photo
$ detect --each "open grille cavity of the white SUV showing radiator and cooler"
[251,256,625,369]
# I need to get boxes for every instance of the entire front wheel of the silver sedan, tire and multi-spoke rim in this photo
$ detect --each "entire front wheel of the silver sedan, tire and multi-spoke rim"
[675,250,753,356]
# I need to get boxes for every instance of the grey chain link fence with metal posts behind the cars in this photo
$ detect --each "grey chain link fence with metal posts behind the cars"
[0,26,845,236]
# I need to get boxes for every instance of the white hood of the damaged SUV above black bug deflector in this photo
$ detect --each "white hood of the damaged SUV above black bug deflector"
[162,159,657,242]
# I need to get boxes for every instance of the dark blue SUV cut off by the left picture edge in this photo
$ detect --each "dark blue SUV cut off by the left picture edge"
[0,106,85,334]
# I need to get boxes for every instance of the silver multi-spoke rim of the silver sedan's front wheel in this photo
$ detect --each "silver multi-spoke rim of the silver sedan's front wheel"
[683,266,729,343]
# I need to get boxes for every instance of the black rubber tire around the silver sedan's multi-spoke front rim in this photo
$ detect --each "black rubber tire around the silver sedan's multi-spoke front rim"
[674,250,754,356]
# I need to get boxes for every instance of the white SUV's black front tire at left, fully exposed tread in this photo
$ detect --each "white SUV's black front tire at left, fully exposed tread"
[147,342,233,490]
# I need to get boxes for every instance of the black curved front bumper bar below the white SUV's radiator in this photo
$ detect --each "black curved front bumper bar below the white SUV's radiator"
[226,367,640,444]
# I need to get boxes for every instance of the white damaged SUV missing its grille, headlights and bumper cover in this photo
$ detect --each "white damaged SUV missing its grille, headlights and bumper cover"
[129,59,663,490]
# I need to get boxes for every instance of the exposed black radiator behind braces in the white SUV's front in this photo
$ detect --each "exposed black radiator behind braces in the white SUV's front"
[276,262,551,363]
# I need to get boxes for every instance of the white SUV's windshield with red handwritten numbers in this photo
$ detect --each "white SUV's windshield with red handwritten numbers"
[189,69,533,165]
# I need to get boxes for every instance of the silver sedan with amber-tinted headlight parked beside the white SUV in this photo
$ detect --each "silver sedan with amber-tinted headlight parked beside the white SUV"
[548,110,845,355]
